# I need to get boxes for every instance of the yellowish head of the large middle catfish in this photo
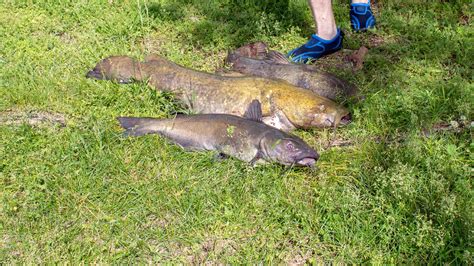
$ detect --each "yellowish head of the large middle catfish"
[303,103,351,127]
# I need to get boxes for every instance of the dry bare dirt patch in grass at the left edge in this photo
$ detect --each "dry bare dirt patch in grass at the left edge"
[0,110,66,127]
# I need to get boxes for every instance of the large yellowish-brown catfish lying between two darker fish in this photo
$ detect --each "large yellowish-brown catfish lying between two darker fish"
[87,55,350,131]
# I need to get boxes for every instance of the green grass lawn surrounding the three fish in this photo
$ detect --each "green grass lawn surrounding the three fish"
[0,0,474,264]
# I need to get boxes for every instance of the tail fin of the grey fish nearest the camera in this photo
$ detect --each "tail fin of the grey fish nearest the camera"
[117,117,162,136]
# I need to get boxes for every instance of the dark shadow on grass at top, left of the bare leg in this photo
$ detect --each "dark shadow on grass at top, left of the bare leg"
[148,0,313,47]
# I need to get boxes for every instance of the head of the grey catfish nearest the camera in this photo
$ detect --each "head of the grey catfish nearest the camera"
[260,133,319,167]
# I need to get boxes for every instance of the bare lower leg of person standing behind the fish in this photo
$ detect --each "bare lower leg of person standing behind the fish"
[309,0,337,40]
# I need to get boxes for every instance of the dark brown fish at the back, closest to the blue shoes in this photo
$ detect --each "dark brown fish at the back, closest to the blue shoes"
[226,42,358,100]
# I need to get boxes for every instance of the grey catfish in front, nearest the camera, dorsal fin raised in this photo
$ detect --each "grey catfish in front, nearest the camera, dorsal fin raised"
[118,100,319,167]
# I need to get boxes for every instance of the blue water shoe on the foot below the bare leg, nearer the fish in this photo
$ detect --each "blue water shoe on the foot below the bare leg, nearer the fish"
[288,28,342,63]
